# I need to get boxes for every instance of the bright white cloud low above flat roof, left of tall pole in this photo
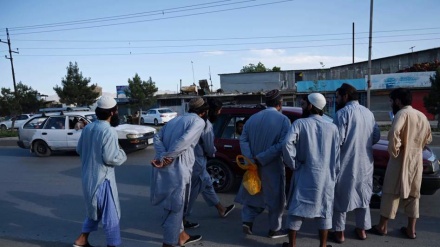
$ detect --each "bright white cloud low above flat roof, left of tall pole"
[242,49,359,70]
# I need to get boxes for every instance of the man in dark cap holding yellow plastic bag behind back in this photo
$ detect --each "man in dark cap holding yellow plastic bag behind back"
[235,89,290,238]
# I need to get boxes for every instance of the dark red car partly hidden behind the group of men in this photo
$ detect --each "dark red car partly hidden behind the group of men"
[207,105,440,206]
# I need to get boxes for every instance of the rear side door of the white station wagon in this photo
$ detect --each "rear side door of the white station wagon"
[41,116,72,150]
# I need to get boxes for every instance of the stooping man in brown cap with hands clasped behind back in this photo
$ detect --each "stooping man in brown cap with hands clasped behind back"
[151,97,208,247]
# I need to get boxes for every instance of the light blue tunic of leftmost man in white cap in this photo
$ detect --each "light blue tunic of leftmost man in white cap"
[76,120,127,220]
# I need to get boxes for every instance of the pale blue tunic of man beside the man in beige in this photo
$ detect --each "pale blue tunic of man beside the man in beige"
[334,101,380,212]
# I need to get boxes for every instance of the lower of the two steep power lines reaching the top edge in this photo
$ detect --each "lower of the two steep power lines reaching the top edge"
[4,0,293,35]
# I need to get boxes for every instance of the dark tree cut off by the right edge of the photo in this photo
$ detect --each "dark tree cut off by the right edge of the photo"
[423,67,440,128]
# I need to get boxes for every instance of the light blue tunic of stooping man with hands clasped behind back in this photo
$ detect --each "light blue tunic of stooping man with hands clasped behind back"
[151,113,205,212]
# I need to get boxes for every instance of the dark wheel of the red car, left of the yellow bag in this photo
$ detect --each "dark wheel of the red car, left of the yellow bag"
[206,160,235,192]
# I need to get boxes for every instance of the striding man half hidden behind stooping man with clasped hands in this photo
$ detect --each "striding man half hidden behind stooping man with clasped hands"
[183,98,235,228]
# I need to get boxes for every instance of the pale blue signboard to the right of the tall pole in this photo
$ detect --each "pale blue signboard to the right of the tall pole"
[365,71,435,90]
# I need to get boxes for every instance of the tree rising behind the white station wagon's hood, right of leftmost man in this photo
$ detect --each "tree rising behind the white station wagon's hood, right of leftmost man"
[125,73,158,123]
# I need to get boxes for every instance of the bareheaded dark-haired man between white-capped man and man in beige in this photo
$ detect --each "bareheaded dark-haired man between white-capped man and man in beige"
[332,83,380,243]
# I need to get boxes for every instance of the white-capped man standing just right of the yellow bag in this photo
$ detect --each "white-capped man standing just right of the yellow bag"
[282,93,340,247]
